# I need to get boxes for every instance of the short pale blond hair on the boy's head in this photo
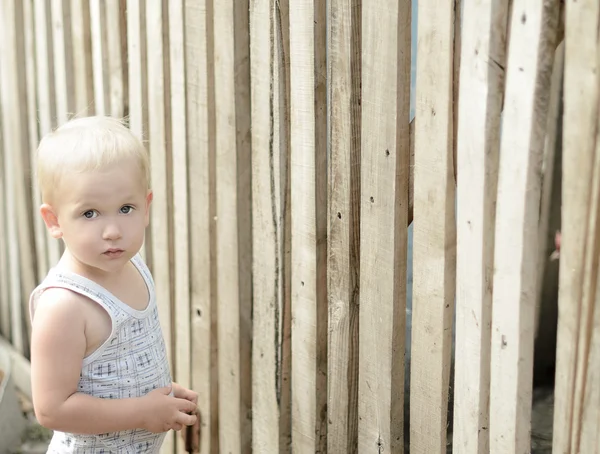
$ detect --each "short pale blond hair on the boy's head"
[36,116,150,202]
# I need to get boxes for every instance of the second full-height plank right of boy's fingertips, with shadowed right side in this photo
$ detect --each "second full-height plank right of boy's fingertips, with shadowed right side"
[214,0,252,453]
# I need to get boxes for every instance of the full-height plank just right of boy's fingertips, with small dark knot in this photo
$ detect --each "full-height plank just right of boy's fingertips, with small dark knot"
[185,0,219,454]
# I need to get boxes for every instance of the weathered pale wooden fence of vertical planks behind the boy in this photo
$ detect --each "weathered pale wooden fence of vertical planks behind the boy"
[0,0,600,454]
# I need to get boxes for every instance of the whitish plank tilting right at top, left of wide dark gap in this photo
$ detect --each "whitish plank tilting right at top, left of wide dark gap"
[490,0,558,454]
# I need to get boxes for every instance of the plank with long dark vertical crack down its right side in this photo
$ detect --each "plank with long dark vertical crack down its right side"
[250,0,291,453]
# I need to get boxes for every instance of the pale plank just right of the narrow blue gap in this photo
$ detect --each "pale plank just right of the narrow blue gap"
[410,2,456,453]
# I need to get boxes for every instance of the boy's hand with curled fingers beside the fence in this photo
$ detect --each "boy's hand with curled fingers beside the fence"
[141,387,197,433]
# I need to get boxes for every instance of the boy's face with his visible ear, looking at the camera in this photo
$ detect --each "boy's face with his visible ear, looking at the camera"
[42,161,152,272]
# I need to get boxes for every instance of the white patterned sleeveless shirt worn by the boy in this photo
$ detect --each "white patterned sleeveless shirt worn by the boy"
[29,254,171,454]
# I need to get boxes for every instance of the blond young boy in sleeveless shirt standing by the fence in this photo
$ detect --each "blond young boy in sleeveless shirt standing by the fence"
[30,117,197,454]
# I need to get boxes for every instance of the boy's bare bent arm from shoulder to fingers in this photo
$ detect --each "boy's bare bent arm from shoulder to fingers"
[31,291,196,434]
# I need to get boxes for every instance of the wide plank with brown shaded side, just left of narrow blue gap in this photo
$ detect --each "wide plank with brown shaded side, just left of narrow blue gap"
[358,0,411,453]
